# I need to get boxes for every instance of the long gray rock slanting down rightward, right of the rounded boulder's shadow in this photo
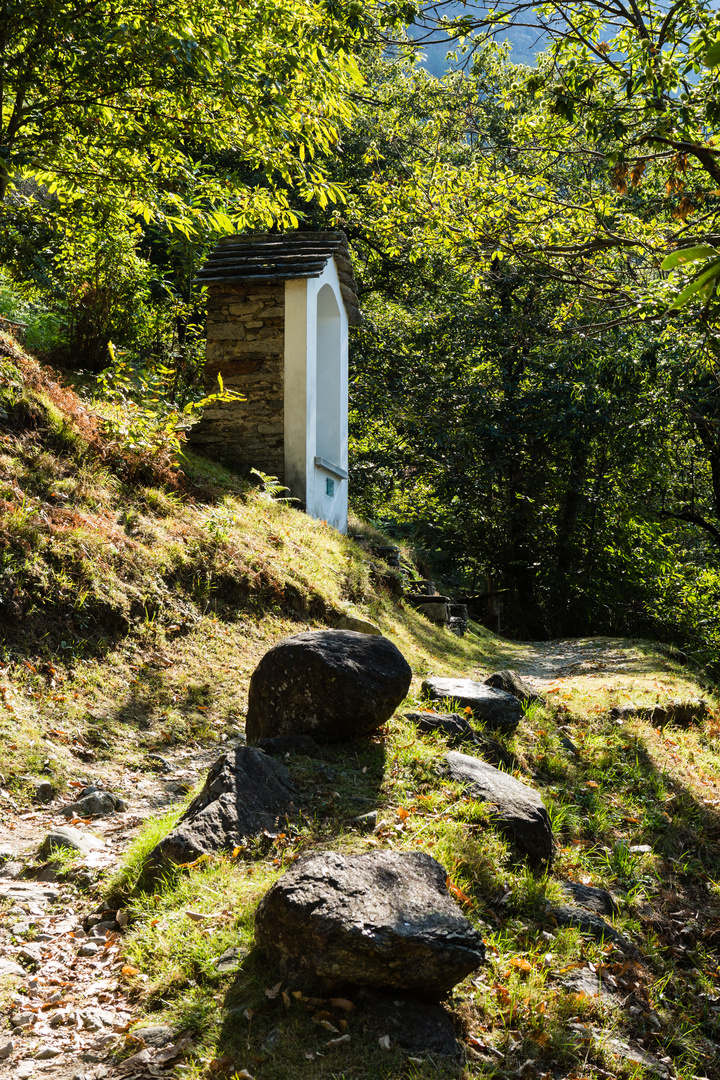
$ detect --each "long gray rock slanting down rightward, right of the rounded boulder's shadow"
[445,751,553,863]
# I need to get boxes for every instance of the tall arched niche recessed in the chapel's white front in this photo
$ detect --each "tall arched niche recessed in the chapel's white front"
[315,285,343,464]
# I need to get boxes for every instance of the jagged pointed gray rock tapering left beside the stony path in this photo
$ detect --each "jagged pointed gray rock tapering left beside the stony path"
[147,746,298,872]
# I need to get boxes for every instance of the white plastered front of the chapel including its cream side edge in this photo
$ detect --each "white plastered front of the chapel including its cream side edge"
[284,259,348,532]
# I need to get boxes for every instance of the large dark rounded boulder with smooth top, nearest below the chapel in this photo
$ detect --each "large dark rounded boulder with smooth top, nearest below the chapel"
[245,630,412,743]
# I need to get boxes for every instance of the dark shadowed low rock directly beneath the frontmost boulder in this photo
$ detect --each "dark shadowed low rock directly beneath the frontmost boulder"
[356,989,460,1057]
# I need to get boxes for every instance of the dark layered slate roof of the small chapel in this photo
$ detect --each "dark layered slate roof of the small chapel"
[195,232,362,325]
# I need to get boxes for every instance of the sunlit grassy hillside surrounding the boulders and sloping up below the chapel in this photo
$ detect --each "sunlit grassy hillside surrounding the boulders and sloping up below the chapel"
[0,338,720,1080]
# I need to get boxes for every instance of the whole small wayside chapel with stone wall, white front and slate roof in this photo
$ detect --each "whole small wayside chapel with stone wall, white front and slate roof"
[191,232,361,532]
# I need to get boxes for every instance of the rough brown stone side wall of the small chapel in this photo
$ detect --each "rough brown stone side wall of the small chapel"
[189,282,285,481]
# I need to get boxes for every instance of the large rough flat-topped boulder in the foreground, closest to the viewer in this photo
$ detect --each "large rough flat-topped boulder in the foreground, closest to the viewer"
[255,851,485,998]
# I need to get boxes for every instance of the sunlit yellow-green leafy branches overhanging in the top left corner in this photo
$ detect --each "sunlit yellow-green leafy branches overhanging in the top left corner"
[0,0,382,232]
